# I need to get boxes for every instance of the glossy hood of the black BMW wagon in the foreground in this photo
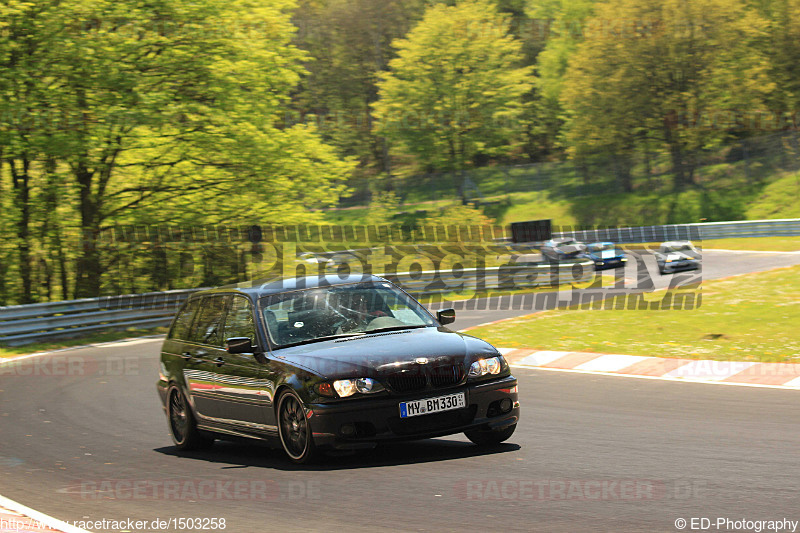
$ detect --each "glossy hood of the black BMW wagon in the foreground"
[274,327,498,379]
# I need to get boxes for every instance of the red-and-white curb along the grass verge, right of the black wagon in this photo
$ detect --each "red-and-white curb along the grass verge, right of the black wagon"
[500,348,800,390]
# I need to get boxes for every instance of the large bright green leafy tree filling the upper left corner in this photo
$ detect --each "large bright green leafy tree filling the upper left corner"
[0,0,353,299]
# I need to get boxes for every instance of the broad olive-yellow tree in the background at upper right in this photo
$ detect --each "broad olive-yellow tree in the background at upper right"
[560,0,774,190]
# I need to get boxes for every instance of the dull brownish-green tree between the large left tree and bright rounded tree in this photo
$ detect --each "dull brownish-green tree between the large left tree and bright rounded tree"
[286,0,426,181]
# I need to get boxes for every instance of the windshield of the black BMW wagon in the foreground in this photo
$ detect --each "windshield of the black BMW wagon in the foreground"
[261,282,436,347]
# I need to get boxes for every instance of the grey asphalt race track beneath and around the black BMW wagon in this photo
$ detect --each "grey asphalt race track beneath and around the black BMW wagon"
[0,252,800,532]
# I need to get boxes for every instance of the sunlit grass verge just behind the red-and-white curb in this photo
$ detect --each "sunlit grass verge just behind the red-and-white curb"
[469,267,800,363]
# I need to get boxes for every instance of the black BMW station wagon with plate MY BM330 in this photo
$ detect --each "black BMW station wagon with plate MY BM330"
[158,276,520,463]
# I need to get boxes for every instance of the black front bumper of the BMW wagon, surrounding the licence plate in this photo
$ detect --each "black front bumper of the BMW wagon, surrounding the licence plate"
[308,376,520,449]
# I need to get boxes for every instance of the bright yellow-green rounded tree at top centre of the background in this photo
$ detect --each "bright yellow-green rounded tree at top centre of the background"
[373,0,531,184]
